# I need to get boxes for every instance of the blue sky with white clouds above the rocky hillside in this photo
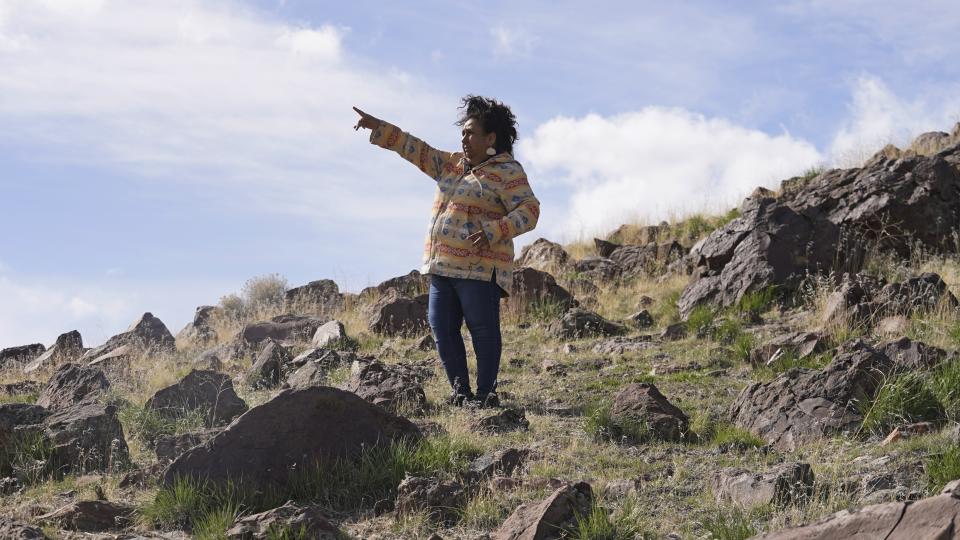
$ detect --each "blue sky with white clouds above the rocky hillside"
[0,0,960,348]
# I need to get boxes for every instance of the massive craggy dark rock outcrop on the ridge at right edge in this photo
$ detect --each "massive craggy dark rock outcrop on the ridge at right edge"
[679,146,960,317]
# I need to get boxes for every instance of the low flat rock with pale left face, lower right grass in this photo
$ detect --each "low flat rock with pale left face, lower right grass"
[711,462,813,508]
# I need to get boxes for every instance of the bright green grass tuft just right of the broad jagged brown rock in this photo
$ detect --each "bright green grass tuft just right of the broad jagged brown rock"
[860,373,944,436]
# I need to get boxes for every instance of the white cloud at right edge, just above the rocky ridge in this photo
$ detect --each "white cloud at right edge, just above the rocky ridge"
[830,75,960,166]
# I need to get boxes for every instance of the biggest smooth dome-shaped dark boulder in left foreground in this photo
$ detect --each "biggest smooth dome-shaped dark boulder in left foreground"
[163,387,420,488]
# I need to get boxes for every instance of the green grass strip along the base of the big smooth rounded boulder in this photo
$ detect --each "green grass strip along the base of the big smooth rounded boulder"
[141,437,480,538]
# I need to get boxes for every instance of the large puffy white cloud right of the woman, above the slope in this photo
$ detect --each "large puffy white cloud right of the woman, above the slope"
[520,107,821,239]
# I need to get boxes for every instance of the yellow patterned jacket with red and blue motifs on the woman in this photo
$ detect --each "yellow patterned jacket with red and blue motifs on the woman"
[370,122,540,296]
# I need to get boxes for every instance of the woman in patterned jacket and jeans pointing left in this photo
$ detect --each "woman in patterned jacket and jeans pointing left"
[354,96,540,407]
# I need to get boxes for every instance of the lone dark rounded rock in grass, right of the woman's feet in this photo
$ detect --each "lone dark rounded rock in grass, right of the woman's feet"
[610,383,690,442]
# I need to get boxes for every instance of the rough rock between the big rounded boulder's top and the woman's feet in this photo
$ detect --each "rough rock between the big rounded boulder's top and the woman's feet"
[345,360,431,412]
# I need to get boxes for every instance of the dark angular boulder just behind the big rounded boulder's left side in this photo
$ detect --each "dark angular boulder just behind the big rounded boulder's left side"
[144,370,247,426]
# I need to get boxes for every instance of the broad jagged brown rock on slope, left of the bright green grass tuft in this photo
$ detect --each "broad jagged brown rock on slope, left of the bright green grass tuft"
[730,341,893,451]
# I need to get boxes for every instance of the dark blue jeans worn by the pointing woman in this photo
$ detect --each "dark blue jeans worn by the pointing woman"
[427,275,502,396]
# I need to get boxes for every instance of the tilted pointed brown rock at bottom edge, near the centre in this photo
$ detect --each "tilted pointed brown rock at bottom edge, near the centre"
[492,482,593,540]
